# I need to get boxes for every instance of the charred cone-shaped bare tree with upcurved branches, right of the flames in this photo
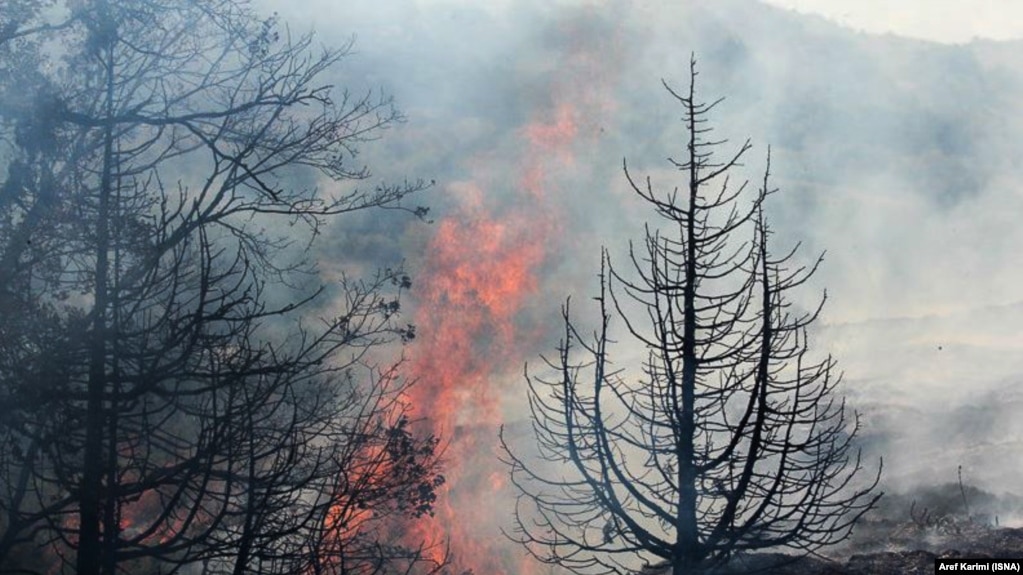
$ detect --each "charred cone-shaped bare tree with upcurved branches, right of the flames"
[501,54,880,575]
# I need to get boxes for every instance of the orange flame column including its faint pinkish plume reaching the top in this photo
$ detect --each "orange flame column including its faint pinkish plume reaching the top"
[410,7,614,575]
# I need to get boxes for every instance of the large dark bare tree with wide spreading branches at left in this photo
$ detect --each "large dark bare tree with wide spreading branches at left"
[0,0,442,575]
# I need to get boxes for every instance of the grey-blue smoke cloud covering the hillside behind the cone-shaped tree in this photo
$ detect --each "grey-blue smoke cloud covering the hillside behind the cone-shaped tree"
[260,0,1023,536]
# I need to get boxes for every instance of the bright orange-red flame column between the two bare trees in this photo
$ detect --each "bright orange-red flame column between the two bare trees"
[412,117,576,575]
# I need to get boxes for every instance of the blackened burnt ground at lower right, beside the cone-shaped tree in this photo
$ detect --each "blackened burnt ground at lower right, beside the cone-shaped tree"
[642,484,1023,575]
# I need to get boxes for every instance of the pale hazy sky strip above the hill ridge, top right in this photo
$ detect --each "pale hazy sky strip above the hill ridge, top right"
[766,0,1023,43]
